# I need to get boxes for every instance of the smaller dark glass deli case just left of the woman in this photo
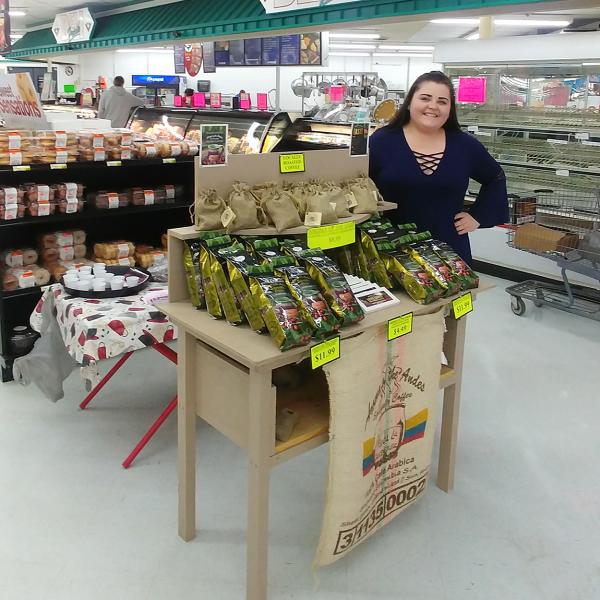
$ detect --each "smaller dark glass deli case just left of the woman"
[273,118,376,152]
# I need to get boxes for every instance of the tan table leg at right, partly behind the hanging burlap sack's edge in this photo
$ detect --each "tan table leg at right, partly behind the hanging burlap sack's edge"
[437,316,467,492]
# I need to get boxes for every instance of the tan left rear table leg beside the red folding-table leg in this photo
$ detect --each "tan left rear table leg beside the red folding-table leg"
[177,329,197,542]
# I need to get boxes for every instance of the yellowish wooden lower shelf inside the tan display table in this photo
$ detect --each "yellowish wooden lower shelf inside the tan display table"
[273,365,456,463]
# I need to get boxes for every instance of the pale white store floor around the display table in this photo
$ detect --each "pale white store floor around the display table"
[0,280,600,600]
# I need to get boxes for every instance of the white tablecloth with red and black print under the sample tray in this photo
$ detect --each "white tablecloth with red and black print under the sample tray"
[30,284,177,388]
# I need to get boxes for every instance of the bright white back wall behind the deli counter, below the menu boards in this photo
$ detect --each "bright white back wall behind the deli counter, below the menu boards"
[72,51,441,112]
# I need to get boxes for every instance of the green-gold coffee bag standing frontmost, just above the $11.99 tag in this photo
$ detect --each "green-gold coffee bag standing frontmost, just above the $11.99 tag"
[250,274,312,350]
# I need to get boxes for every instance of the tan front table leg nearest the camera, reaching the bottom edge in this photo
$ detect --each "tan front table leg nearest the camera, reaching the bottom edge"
[246,370,276,600]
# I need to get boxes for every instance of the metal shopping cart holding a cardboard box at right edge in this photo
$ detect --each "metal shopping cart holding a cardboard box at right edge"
[506,190,600,321]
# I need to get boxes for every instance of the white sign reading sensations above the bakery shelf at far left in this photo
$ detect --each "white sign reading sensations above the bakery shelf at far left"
[0,73,49,129]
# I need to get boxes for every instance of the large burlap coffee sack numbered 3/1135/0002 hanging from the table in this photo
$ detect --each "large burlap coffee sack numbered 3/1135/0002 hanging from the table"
[313,311,444,568]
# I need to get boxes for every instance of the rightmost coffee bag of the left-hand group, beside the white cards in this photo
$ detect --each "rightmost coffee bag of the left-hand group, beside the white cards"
[301,249,365,325]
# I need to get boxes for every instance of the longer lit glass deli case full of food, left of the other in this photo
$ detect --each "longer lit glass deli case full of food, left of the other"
[127,106,292,154]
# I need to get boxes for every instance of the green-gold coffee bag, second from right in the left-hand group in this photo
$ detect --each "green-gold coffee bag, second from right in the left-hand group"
[275,266,340,338]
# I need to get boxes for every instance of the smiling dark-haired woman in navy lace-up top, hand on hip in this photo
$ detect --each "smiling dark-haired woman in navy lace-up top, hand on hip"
[369,71,508,263]
